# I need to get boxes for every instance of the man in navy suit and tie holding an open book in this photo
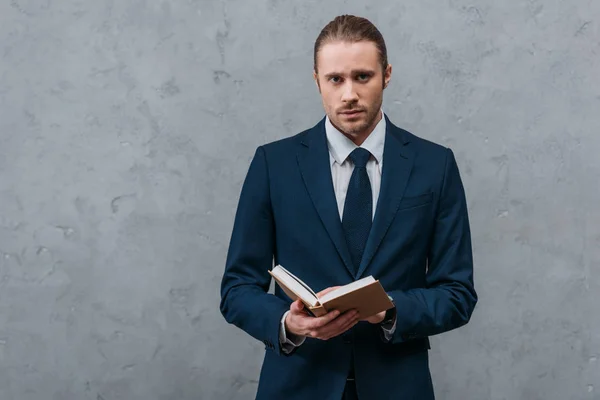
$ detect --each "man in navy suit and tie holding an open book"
[221,16,477,400]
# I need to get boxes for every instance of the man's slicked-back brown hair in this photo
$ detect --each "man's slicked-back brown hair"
[314,15,388,72]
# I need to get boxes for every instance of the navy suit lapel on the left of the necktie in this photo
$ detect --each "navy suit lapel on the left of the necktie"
[297,119,356,276]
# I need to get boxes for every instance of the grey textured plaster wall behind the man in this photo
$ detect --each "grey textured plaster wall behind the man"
[0,0,600,400]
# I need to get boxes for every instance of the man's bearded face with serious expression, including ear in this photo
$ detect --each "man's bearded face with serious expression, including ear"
[314,41,392,145]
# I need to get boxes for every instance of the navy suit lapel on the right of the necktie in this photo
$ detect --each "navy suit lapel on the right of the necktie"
[355,116,414,279]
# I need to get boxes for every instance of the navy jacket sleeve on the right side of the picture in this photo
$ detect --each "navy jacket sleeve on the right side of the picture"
[389,149,477,343]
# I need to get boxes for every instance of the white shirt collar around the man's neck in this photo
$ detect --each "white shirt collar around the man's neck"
[325,111,386,165]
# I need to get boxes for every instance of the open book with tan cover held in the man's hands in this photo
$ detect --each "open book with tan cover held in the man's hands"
[269,265,394,318]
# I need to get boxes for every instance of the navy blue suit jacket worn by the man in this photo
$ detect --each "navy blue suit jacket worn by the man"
[220,117,477,400]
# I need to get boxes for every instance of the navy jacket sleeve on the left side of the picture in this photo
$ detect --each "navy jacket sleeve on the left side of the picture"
[220,147,289,354]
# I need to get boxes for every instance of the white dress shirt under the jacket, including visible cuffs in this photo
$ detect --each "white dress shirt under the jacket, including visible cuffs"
[279,111,396,353]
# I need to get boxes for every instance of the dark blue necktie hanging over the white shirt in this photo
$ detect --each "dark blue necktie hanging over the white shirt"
[342,148,373,272]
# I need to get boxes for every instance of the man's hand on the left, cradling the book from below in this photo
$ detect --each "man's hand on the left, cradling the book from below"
[285,300,359,340]
